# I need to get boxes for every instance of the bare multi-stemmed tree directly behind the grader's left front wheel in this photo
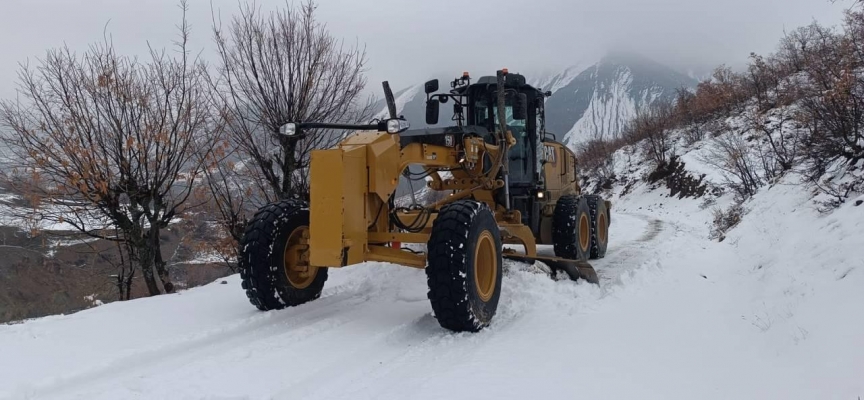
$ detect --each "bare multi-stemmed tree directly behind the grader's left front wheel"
[209,0,372,253]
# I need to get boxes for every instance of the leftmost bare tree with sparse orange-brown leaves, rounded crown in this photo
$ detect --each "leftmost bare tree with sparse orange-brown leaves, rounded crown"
[0,2,213,295]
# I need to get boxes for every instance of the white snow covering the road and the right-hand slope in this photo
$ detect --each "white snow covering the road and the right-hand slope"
[0,159,864,399]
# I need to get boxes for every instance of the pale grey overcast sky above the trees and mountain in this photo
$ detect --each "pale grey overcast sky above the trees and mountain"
[0,0,850,96]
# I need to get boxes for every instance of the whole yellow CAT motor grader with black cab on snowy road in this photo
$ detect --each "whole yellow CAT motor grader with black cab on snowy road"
[239,69,610,331]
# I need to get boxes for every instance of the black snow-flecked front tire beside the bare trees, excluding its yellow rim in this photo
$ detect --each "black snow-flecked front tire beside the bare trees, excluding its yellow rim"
[239,201,327,311]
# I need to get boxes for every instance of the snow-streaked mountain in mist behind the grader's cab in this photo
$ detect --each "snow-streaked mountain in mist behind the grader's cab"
[378,53,697,147]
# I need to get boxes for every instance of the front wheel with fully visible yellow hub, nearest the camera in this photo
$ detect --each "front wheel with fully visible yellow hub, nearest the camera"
[426,200,504,332]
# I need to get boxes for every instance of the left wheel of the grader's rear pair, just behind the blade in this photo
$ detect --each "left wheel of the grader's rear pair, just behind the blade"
[552,195,591,261]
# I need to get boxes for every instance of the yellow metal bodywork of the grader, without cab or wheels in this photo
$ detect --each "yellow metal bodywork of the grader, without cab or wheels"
[304,125,580,268]
